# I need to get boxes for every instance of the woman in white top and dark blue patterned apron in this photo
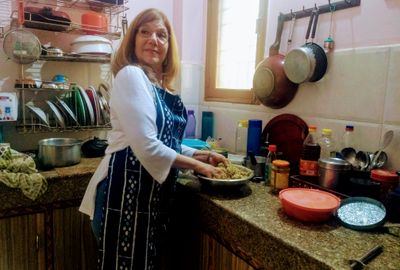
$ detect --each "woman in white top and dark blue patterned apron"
[80,9,226,270]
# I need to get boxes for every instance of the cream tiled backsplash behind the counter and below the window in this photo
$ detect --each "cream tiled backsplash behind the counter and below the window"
[181,45,400,170]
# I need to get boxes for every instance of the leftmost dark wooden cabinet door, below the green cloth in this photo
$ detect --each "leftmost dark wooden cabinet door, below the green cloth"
[0,214,45,270]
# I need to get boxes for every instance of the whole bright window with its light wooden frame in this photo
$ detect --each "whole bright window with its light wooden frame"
[205,0,268,103]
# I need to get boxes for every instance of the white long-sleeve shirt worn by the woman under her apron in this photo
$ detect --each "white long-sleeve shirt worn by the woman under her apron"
[79,66,196,219]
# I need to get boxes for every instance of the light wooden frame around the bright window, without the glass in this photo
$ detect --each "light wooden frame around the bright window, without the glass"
[204,0,268,104]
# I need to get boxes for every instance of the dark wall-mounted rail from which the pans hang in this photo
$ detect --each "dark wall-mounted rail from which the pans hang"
[283,0,361,21]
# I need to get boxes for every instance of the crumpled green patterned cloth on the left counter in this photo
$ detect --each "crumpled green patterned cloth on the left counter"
[0,150,47,200]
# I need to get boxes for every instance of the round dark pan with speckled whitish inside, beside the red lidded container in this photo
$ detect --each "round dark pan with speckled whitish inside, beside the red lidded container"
[335,197,400,231]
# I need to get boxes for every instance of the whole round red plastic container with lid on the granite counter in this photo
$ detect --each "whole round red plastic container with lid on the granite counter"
[279,188,340,222]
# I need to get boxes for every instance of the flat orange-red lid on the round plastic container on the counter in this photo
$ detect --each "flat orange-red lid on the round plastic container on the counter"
[279,188,340,212]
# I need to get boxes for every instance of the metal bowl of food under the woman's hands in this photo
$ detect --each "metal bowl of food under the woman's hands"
[197,163,254,186]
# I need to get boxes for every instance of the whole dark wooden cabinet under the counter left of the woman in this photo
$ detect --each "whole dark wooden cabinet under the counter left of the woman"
[0,207,97,270]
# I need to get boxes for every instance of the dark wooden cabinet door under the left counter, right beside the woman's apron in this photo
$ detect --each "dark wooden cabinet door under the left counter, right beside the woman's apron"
[53,207,97,270]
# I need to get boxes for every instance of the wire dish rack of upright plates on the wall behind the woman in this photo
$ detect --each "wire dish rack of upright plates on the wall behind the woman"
[16,88,111,133]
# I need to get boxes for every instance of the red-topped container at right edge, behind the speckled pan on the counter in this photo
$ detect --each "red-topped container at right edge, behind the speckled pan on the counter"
[370,169,399,204]
